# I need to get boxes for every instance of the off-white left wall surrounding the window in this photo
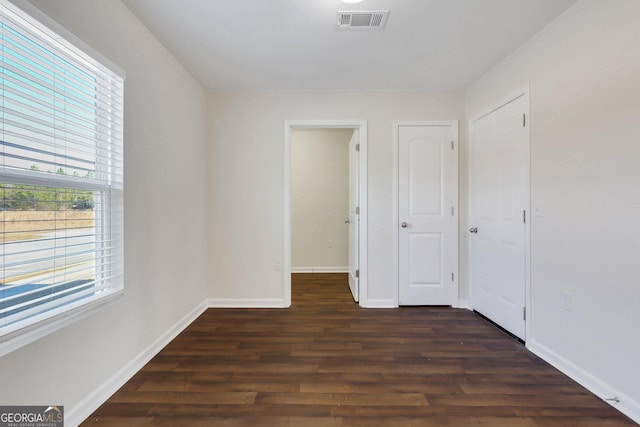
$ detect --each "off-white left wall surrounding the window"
[0,0,207,425]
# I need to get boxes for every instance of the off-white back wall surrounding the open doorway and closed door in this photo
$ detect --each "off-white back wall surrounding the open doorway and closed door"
[208,91,464,304]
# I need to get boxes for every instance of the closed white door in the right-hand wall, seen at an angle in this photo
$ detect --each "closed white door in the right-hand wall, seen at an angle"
[469,94,529,339]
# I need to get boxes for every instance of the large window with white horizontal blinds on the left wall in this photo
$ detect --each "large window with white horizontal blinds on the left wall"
[0,0,124,354]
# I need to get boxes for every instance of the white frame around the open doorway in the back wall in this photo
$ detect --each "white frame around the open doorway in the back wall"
[282,120,368,307]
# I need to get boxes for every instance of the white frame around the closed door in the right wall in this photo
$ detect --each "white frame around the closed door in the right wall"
[464,83,533,345]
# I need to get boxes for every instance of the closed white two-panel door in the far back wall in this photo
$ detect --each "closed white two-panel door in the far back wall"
[397,122,458,305]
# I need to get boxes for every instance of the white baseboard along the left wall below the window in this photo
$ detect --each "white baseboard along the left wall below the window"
[64,302,207,427]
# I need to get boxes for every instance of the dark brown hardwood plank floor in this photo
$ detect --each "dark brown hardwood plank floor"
[82,274,636,427]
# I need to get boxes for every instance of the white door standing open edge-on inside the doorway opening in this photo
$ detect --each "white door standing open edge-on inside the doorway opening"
[348,129,360,302]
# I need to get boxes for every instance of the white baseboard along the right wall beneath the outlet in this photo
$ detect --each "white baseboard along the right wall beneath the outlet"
[526,339,640,424]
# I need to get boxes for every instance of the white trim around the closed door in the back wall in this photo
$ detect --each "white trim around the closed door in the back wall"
[391,120,460,307]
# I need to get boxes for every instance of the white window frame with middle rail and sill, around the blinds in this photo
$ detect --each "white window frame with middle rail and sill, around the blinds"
[0,0,125,356]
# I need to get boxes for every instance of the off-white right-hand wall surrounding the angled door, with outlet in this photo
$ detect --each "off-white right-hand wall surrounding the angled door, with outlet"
[462,0,640,420]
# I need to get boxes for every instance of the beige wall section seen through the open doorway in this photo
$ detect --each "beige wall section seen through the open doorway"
[291,129,353,272]
